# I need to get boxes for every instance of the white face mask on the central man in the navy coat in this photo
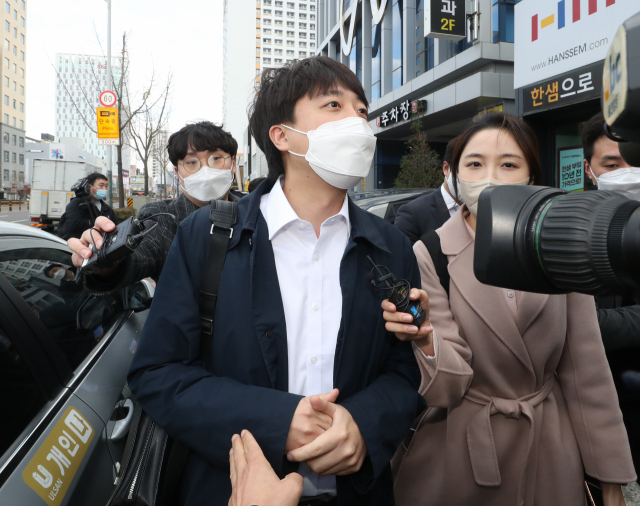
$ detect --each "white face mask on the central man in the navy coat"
[281,117,376,190]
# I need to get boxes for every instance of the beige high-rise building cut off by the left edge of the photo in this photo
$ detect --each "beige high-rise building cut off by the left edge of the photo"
[0,0,27,198]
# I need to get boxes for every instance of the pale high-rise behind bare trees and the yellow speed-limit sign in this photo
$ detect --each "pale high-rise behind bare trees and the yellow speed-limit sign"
[55,53,129,162]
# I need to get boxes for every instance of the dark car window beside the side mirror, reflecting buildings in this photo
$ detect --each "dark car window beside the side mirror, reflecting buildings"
[0,248,114,370]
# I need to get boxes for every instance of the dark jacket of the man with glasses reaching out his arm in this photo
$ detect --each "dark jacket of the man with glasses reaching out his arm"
[84,190,242,294]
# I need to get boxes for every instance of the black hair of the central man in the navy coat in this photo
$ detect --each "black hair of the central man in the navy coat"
[249,56,369,180]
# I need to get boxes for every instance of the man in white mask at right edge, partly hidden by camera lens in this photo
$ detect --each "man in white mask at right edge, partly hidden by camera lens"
[582,113,640,468]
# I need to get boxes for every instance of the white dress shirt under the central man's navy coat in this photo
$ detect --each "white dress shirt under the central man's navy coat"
[260,178,351,496]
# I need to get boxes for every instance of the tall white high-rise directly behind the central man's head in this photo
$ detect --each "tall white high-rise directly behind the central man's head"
[223,0,316,184]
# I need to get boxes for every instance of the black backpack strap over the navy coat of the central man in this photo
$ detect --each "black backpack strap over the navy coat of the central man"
[199,200,238,361]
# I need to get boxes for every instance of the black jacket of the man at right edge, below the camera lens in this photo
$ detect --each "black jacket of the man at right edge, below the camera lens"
[596,295,640,469]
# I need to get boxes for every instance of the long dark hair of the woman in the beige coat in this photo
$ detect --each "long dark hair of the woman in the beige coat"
[451,112,542,194]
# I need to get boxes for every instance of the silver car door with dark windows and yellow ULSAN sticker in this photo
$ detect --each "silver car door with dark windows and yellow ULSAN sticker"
[0,236,151,506]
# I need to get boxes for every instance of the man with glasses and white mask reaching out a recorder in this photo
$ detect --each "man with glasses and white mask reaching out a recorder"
[67,121,241,294]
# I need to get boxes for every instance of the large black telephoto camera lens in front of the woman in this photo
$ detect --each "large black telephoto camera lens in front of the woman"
[474,185,640,295]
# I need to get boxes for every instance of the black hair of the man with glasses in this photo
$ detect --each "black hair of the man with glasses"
[167,121,238,167]
